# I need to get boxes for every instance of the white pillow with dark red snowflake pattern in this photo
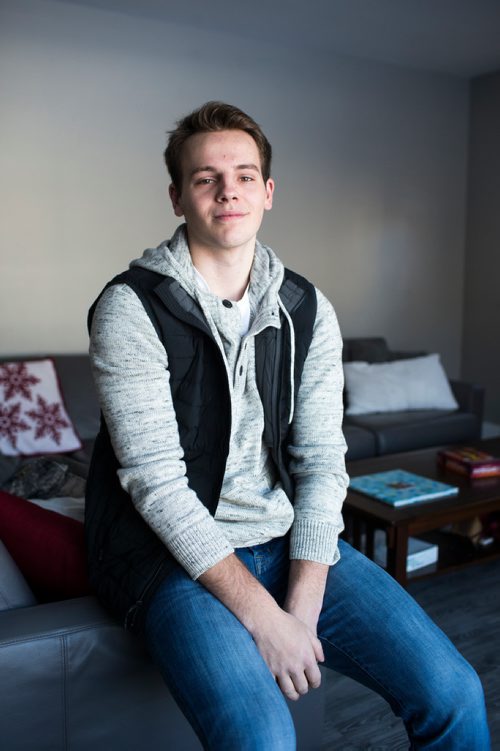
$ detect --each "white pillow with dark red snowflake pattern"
[0,359,82,456]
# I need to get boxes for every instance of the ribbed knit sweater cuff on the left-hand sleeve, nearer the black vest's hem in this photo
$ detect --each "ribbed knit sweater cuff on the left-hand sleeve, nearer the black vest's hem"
[168,523,234,579]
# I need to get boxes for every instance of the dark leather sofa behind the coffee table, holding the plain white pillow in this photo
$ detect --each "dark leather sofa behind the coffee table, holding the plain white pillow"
[343,337,484,461]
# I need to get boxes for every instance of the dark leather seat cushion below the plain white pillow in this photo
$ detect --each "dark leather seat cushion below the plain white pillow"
[348,410,478,454]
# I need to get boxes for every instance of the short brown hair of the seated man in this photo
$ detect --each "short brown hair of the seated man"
[164,102,272,193]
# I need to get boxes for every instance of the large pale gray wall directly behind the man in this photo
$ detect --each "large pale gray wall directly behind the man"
[0,0,468,375]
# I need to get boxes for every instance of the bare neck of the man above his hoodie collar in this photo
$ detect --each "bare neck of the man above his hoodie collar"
[190,241,255,300]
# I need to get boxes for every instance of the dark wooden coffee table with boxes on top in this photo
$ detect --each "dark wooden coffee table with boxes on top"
[344,438,500,586]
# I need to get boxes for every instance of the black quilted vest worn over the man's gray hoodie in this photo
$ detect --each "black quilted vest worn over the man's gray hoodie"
[85,266,317,631]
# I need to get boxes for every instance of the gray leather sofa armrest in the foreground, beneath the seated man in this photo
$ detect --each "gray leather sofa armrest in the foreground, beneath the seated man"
[0,597,200,751]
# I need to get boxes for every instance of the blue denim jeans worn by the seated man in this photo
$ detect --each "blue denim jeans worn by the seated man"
[146,537,490,751]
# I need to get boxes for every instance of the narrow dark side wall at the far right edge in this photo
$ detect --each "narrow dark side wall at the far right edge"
[463,72,500,423]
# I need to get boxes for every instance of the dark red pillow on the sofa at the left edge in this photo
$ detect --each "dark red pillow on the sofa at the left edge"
[0,491,90,602]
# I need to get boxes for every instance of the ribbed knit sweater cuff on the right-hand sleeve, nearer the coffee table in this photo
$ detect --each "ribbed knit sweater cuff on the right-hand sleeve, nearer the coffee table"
[290,519,340,566]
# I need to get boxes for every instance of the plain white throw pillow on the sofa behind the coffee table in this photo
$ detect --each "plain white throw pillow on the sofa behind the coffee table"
[344,355,458,415]
